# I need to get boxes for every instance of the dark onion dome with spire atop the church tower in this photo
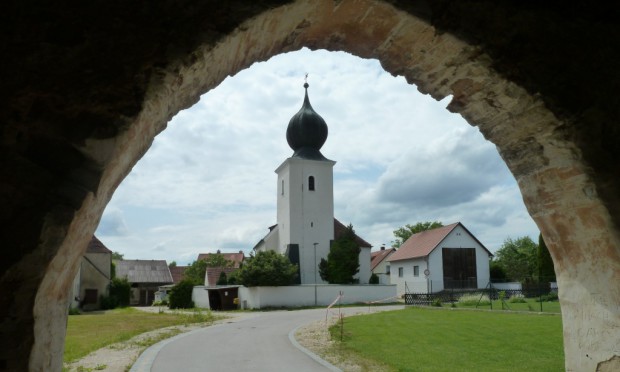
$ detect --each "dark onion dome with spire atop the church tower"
[286,83,328,160]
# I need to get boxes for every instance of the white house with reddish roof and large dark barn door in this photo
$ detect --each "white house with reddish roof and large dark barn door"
[387,222,493,295]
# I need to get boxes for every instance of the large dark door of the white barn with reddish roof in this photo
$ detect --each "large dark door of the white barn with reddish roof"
[442,248,478,289]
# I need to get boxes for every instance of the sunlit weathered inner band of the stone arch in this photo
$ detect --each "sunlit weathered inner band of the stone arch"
[2,1,620,370]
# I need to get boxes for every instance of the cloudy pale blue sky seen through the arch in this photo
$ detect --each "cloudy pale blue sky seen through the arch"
[96,49,538,265]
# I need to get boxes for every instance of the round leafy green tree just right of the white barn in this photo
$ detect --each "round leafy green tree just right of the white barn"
[495,236,538,282]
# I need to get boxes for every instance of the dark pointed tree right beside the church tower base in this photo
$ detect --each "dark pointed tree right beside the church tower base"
[319,225,360,284]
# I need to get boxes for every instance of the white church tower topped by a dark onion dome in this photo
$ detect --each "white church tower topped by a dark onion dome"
[276,83,336,284]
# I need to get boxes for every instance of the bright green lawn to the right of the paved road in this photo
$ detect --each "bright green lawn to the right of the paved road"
[331,307,564,371]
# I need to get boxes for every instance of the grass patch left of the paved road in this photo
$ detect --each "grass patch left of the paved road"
[63,308,215,363]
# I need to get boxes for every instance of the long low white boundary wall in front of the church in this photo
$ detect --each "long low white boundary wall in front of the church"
[237,284,396,309]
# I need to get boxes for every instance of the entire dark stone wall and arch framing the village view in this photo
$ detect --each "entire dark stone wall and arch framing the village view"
[0,0,620,371]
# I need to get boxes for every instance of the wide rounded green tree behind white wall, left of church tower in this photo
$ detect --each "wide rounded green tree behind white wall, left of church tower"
[238,251,297,287]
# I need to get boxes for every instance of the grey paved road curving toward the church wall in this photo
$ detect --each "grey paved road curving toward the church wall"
[131,306,403,372]
